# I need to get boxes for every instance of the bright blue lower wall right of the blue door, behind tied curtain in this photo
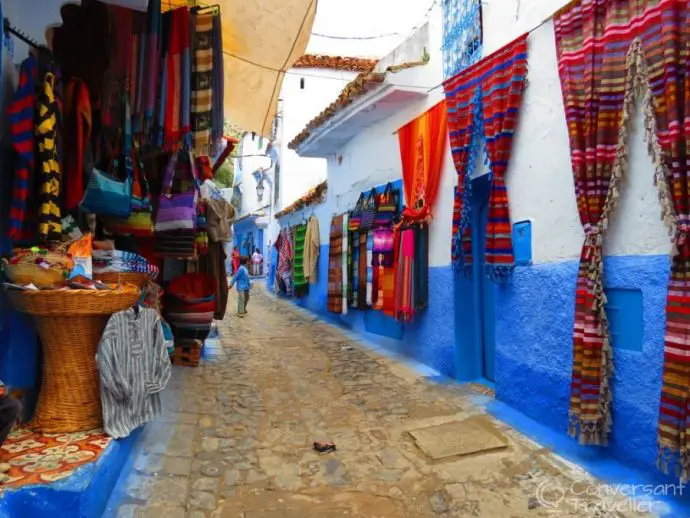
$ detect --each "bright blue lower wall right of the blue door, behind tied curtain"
[496,256,669,476]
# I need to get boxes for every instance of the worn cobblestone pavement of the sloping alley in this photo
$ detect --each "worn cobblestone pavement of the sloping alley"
[105,287,642,518]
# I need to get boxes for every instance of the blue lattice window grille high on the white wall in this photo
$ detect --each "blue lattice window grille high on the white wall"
[443,0,482,79]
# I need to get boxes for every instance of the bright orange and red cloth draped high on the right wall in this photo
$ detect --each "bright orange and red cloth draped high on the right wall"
[398,101,448,223]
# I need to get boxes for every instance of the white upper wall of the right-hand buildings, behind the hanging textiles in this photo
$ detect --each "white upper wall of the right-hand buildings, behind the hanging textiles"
[292,0,670,274]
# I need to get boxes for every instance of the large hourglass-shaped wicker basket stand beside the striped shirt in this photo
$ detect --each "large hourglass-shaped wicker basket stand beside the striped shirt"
[8,285,139,433]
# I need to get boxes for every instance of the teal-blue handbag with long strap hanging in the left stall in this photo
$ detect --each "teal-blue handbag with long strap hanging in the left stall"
[80,99,133,218]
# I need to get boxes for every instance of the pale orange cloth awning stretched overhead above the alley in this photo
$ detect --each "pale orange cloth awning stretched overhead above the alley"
[162,0,317,137]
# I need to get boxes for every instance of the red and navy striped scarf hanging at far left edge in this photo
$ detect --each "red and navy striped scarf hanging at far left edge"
[7,56,38,241]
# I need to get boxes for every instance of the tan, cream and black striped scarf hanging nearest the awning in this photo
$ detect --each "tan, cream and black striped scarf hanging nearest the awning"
[192,14,214,156]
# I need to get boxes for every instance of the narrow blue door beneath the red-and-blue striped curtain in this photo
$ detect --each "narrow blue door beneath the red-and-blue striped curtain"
[471,175,496,381]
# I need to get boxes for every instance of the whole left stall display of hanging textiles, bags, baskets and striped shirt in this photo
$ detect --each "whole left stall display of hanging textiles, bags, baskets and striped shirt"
[3,0,235,438]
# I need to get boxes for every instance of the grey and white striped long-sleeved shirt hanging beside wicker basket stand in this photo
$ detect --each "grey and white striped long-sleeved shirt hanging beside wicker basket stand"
[96,308,171,439]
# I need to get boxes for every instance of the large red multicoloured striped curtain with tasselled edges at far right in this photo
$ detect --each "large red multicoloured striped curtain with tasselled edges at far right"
[554,0,690,464]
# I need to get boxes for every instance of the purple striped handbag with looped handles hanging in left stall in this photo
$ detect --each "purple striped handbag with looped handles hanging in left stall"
[155,152,199,232]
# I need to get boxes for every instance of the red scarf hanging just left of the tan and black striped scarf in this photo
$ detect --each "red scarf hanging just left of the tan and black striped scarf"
[164,7,191,150]
